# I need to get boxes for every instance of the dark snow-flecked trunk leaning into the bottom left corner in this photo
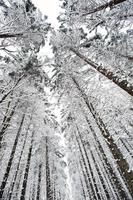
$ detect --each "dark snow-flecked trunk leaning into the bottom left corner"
[0,114,25,199]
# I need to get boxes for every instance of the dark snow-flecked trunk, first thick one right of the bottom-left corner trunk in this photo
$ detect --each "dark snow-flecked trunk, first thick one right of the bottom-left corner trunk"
[20,132,34,200]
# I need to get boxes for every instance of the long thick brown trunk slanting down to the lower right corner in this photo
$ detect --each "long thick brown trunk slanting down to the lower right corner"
[72,77,133,196]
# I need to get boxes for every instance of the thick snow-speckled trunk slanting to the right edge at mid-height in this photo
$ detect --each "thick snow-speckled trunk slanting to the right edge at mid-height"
[70,48,133,96]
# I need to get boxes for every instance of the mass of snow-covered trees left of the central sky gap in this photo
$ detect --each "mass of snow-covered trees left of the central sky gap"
[0,0,69,200]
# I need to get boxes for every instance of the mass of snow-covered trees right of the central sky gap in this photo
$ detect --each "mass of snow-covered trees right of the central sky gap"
[51,1,133,199]
